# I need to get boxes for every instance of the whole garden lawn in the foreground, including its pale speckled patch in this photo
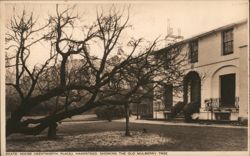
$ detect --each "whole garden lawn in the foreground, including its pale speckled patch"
[6,121,247,151]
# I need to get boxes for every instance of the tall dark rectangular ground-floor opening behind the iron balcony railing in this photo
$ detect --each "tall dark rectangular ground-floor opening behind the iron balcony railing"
[220,74,235,107]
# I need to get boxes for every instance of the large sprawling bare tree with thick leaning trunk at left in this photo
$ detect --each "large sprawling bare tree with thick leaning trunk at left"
[6,5,187,135]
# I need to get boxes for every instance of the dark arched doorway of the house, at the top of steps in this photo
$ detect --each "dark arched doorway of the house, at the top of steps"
[184,71,201,111]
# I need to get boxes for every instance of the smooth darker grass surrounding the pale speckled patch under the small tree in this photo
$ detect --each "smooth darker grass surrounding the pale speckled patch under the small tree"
[7,121,248,151]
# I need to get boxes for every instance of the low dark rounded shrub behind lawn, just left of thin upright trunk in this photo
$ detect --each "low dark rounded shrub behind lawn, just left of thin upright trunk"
[95,105,125,121]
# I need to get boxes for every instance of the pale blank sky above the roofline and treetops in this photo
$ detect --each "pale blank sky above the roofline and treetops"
[5,0,248,66]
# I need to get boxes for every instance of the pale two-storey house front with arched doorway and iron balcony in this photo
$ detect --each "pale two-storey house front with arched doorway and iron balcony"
[153,20,249,121]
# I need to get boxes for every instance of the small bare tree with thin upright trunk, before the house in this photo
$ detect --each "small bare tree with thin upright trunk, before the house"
[103,39,186,136]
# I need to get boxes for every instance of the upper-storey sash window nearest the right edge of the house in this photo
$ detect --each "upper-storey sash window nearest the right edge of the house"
[223,29,233,55]
